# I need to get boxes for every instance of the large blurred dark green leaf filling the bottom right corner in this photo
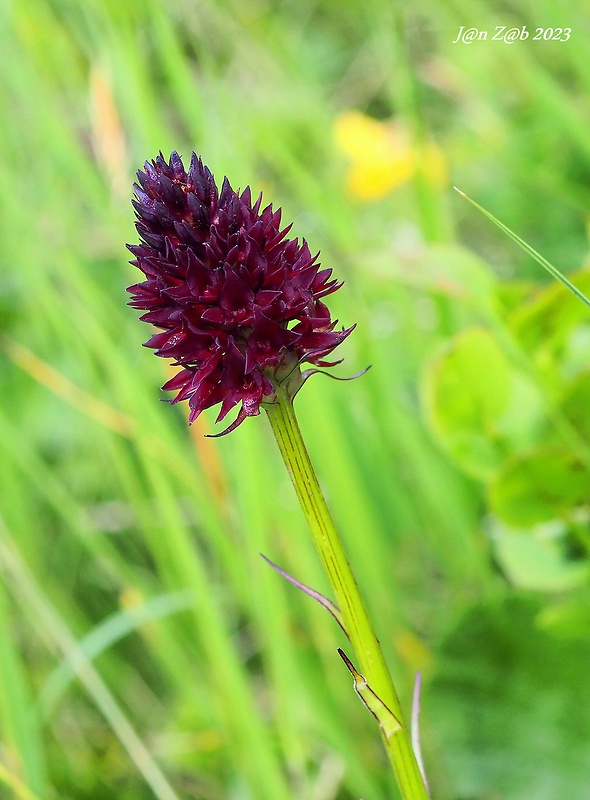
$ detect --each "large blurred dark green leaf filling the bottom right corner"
[423,595,590,800]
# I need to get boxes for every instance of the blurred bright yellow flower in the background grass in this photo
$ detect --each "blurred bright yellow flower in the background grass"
[334,111,447,200]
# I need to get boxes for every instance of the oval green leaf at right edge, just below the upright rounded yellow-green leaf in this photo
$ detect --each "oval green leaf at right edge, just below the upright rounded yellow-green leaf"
[488,447,590,528]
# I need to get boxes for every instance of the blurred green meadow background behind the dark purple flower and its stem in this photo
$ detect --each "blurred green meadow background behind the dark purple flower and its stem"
[0,0,590,800]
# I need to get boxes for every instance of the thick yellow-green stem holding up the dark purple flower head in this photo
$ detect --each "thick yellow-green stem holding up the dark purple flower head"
[266,387,428,800]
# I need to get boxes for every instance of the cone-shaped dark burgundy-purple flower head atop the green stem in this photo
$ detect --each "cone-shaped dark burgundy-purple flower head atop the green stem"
[128,152,352,430]
